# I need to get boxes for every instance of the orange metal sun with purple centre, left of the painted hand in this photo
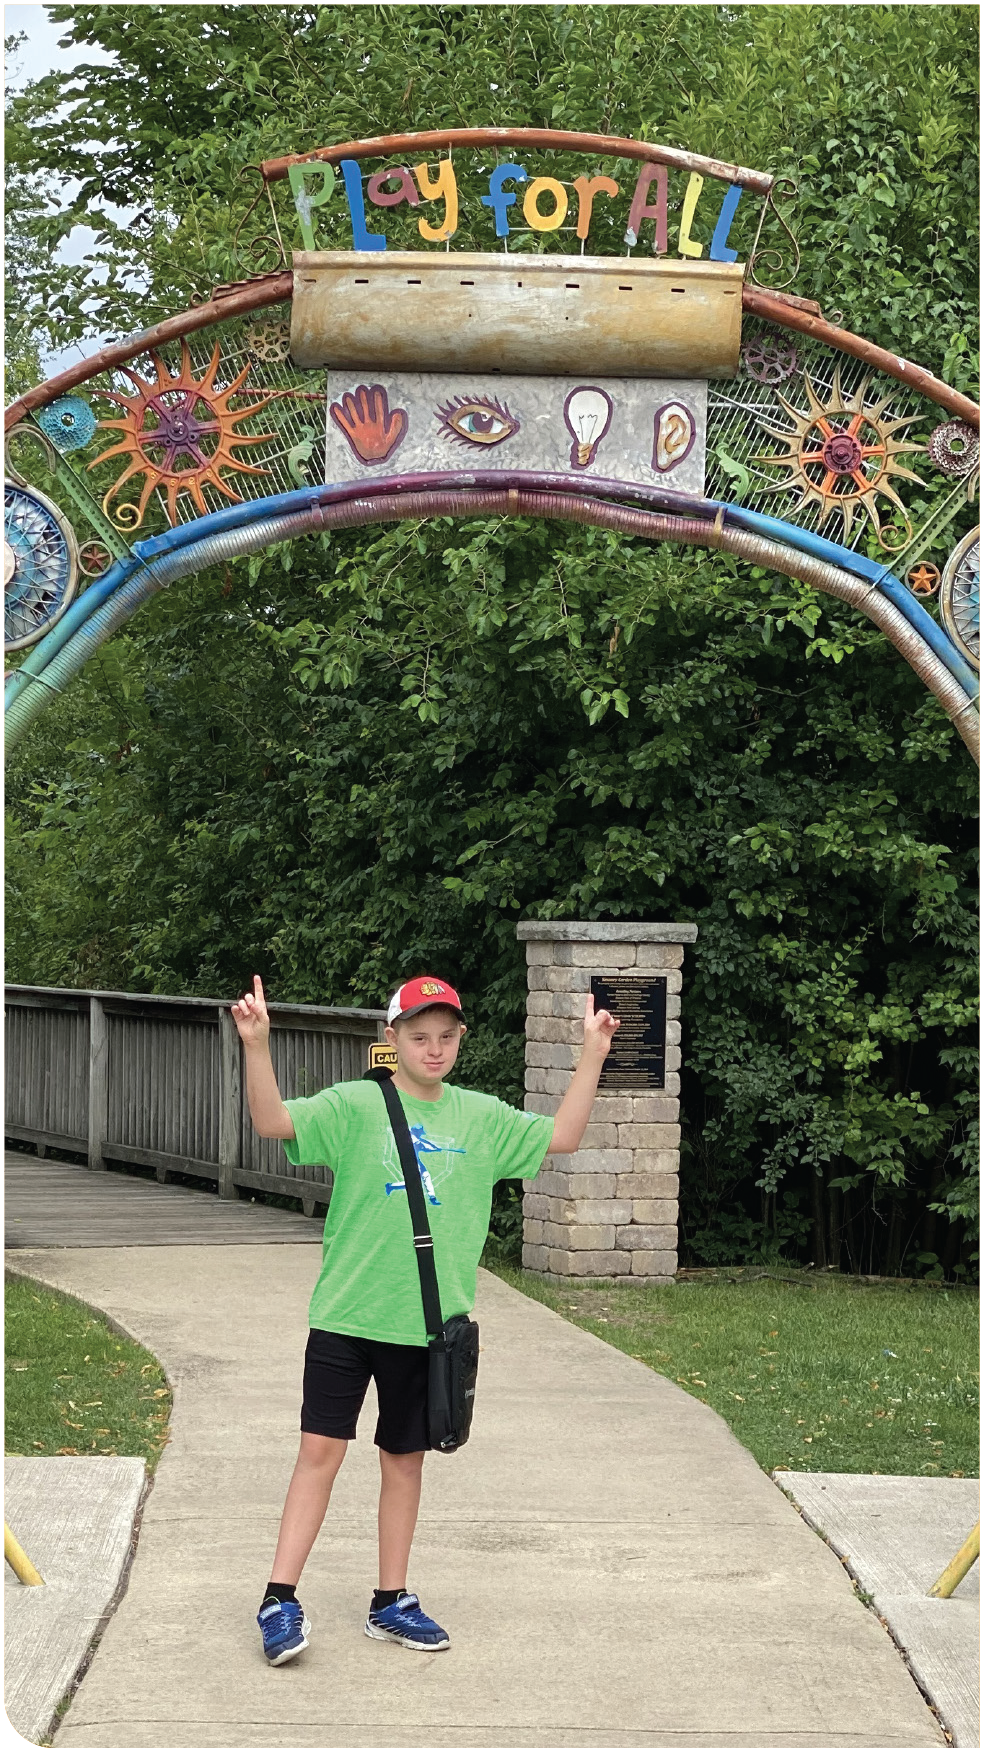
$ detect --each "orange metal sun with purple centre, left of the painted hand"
[89,342,274,529]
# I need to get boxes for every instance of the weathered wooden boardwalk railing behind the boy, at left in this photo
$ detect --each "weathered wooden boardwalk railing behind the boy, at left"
[4,985,386,1217]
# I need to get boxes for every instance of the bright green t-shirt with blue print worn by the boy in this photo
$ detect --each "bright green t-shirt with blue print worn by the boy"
[284,1078,553,1345]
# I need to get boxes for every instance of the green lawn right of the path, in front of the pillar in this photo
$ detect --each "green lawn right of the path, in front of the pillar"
[493,1266,979,1478]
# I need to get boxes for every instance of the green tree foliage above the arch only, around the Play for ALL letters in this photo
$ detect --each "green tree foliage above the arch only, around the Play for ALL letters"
[9,4,977,387]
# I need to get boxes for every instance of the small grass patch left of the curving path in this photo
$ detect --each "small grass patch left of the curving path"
[4,1278,170,1467]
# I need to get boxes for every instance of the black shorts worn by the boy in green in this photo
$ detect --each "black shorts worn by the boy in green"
[300,1327,430,1455]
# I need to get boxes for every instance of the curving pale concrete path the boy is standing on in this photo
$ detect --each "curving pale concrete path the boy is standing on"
[9,1243,945,1748]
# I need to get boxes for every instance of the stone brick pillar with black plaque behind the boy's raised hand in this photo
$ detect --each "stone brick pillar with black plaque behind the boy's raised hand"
[516,920,696,1285]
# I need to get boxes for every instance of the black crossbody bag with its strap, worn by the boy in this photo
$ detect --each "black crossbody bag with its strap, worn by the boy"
[367,1066,479,1455]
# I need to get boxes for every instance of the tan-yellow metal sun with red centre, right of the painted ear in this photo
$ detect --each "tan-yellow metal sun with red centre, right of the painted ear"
[752,366,926,552]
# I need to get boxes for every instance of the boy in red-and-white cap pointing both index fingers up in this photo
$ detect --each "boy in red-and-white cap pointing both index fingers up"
[232,975,617,1667]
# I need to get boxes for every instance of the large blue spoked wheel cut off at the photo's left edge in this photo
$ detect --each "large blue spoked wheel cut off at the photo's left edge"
[4,480,79,652]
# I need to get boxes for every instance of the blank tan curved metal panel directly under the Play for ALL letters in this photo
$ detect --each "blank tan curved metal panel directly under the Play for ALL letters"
[291,249,744,377]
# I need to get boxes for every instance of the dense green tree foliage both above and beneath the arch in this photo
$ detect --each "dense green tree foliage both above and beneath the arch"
[7,5,977,1273]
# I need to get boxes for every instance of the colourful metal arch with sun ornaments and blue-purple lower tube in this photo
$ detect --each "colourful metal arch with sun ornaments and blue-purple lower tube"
[4,130,979,759]
